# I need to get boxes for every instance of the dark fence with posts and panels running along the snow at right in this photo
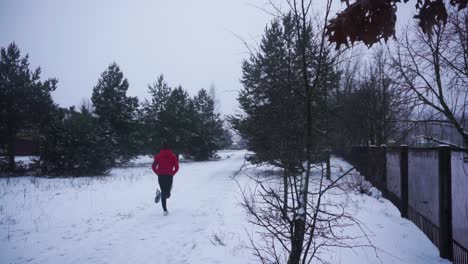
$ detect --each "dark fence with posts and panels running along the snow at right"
[346,146,468,264]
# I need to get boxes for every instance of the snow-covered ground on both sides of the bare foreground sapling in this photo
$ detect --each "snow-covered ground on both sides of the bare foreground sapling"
[0,151,449,264]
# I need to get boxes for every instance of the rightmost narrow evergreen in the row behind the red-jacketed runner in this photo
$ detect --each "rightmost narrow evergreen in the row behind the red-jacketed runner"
[188,89,225,160]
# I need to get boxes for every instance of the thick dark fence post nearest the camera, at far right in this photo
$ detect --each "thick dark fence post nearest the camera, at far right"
[439,145,453,260]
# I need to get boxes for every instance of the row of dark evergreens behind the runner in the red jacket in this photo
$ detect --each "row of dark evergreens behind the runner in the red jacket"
[0,43,231,176]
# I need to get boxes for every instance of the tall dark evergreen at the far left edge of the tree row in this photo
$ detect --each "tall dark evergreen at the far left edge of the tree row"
[0,43,57,171]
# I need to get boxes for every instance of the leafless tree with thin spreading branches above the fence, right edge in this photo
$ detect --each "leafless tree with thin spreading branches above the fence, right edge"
[392,10,468,146]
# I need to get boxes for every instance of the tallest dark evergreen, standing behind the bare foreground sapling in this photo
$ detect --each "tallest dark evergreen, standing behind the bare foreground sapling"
[234,14,339,171]
